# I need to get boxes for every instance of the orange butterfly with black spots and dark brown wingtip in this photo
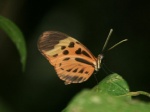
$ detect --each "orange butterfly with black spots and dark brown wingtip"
[38,29,126,84]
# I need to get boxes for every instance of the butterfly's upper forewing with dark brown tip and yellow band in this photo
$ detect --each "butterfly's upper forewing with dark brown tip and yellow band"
[38,31,96,66]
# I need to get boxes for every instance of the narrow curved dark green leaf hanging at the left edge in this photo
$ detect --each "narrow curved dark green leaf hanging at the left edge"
[0,16,27,71]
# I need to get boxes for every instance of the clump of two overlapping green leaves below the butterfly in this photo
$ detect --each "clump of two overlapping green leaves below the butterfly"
[63,73,150,112]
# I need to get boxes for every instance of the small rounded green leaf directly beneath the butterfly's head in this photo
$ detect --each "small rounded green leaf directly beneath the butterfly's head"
[93,73,129,96]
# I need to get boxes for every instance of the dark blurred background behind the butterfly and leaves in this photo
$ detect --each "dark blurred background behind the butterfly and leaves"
[0,0,150,112]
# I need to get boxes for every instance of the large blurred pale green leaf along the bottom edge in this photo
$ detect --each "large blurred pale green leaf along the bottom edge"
[63,90,150,112]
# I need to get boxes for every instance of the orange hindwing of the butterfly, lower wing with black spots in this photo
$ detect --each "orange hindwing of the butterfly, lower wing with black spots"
[55,55,94,84]
